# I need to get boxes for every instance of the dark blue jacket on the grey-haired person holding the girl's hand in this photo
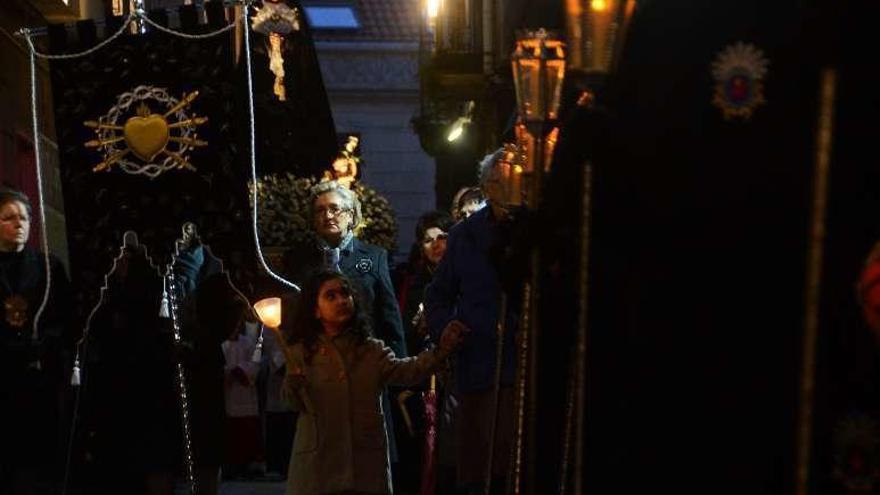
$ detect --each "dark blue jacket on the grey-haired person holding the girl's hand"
[425,207,517,392]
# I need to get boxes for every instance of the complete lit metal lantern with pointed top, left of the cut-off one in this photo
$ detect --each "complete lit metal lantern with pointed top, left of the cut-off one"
[511,28,565,127]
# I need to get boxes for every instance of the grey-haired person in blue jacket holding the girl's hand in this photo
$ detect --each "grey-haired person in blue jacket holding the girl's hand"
[425,150,517,494]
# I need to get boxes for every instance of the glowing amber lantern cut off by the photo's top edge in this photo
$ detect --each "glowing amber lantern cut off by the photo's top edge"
[565,0,636,75]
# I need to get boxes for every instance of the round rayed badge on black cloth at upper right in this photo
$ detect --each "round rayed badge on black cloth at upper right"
[712,41,769,120]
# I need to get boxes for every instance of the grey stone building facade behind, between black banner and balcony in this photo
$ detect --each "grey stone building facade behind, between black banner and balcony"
[304,0,436,261]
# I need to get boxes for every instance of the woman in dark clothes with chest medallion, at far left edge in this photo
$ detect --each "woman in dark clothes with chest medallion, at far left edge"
[0,188,70,494]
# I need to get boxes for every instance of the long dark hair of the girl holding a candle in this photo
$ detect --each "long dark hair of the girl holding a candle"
[287,270,373,363]
